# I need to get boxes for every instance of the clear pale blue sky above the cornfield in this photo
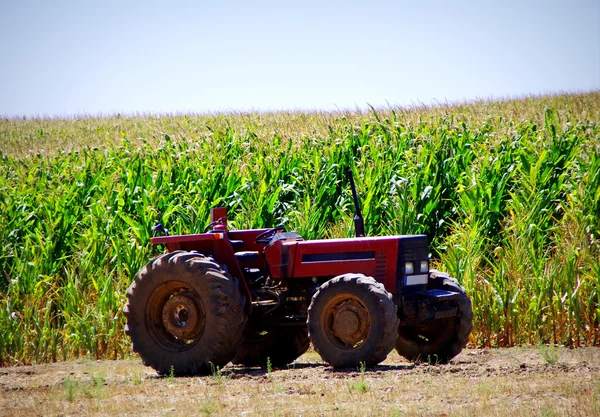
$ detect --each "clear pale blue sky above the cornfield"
[0,0,600,116]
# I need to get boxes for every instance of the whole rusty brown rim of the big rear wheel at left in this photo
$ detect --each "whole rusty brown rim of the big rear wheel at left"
[146,281,206,351]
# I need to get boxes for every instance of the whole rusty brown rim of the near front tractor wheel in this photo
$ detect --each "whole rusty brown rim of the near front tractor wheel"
[322,294,371,350]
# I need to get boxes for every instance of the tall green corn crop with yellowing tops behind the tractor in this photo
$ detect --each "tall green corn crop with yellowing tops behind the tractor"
[0,92,600,365]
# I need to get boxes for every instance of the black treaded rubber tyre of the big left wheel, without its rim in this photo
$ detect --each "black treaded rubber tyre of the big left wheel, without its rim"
[126,252,245,375]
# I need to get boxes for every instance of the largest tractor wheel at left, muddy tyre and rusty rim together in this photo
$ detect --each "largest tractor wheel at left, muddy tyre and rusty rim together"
[124,251,246,375]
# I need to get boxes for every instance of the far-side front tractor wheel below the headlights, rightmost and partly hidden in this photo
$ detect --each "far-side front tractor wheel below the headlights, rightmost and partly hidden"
[396,270,473,363]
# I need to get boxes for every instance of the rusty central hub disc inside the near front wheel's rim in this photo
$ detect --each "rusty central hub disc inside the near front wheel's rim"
[331,300,369,346]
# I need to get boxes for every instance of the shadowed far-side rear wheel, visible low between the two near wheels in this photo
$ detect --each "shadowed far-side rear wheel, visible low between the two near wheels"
[232,327,310,368]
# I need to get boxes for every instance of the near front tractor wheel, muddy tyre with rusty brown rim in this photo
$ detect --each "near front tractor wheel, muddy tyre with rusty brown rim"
[308,274,398,368]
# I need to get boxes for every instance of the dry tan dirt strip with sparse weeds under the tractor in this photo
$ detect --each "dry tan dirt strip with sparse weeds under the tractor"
[0,348,600,417]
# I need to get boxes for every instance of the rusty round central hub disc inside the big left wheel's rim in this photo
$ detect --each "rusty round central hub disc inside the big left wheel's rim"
[162,292,204,340]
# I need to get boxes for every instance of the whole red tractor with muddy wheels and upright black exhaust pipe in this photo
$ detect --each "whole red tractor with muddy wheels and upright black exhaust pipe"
[124,171,473,375]
